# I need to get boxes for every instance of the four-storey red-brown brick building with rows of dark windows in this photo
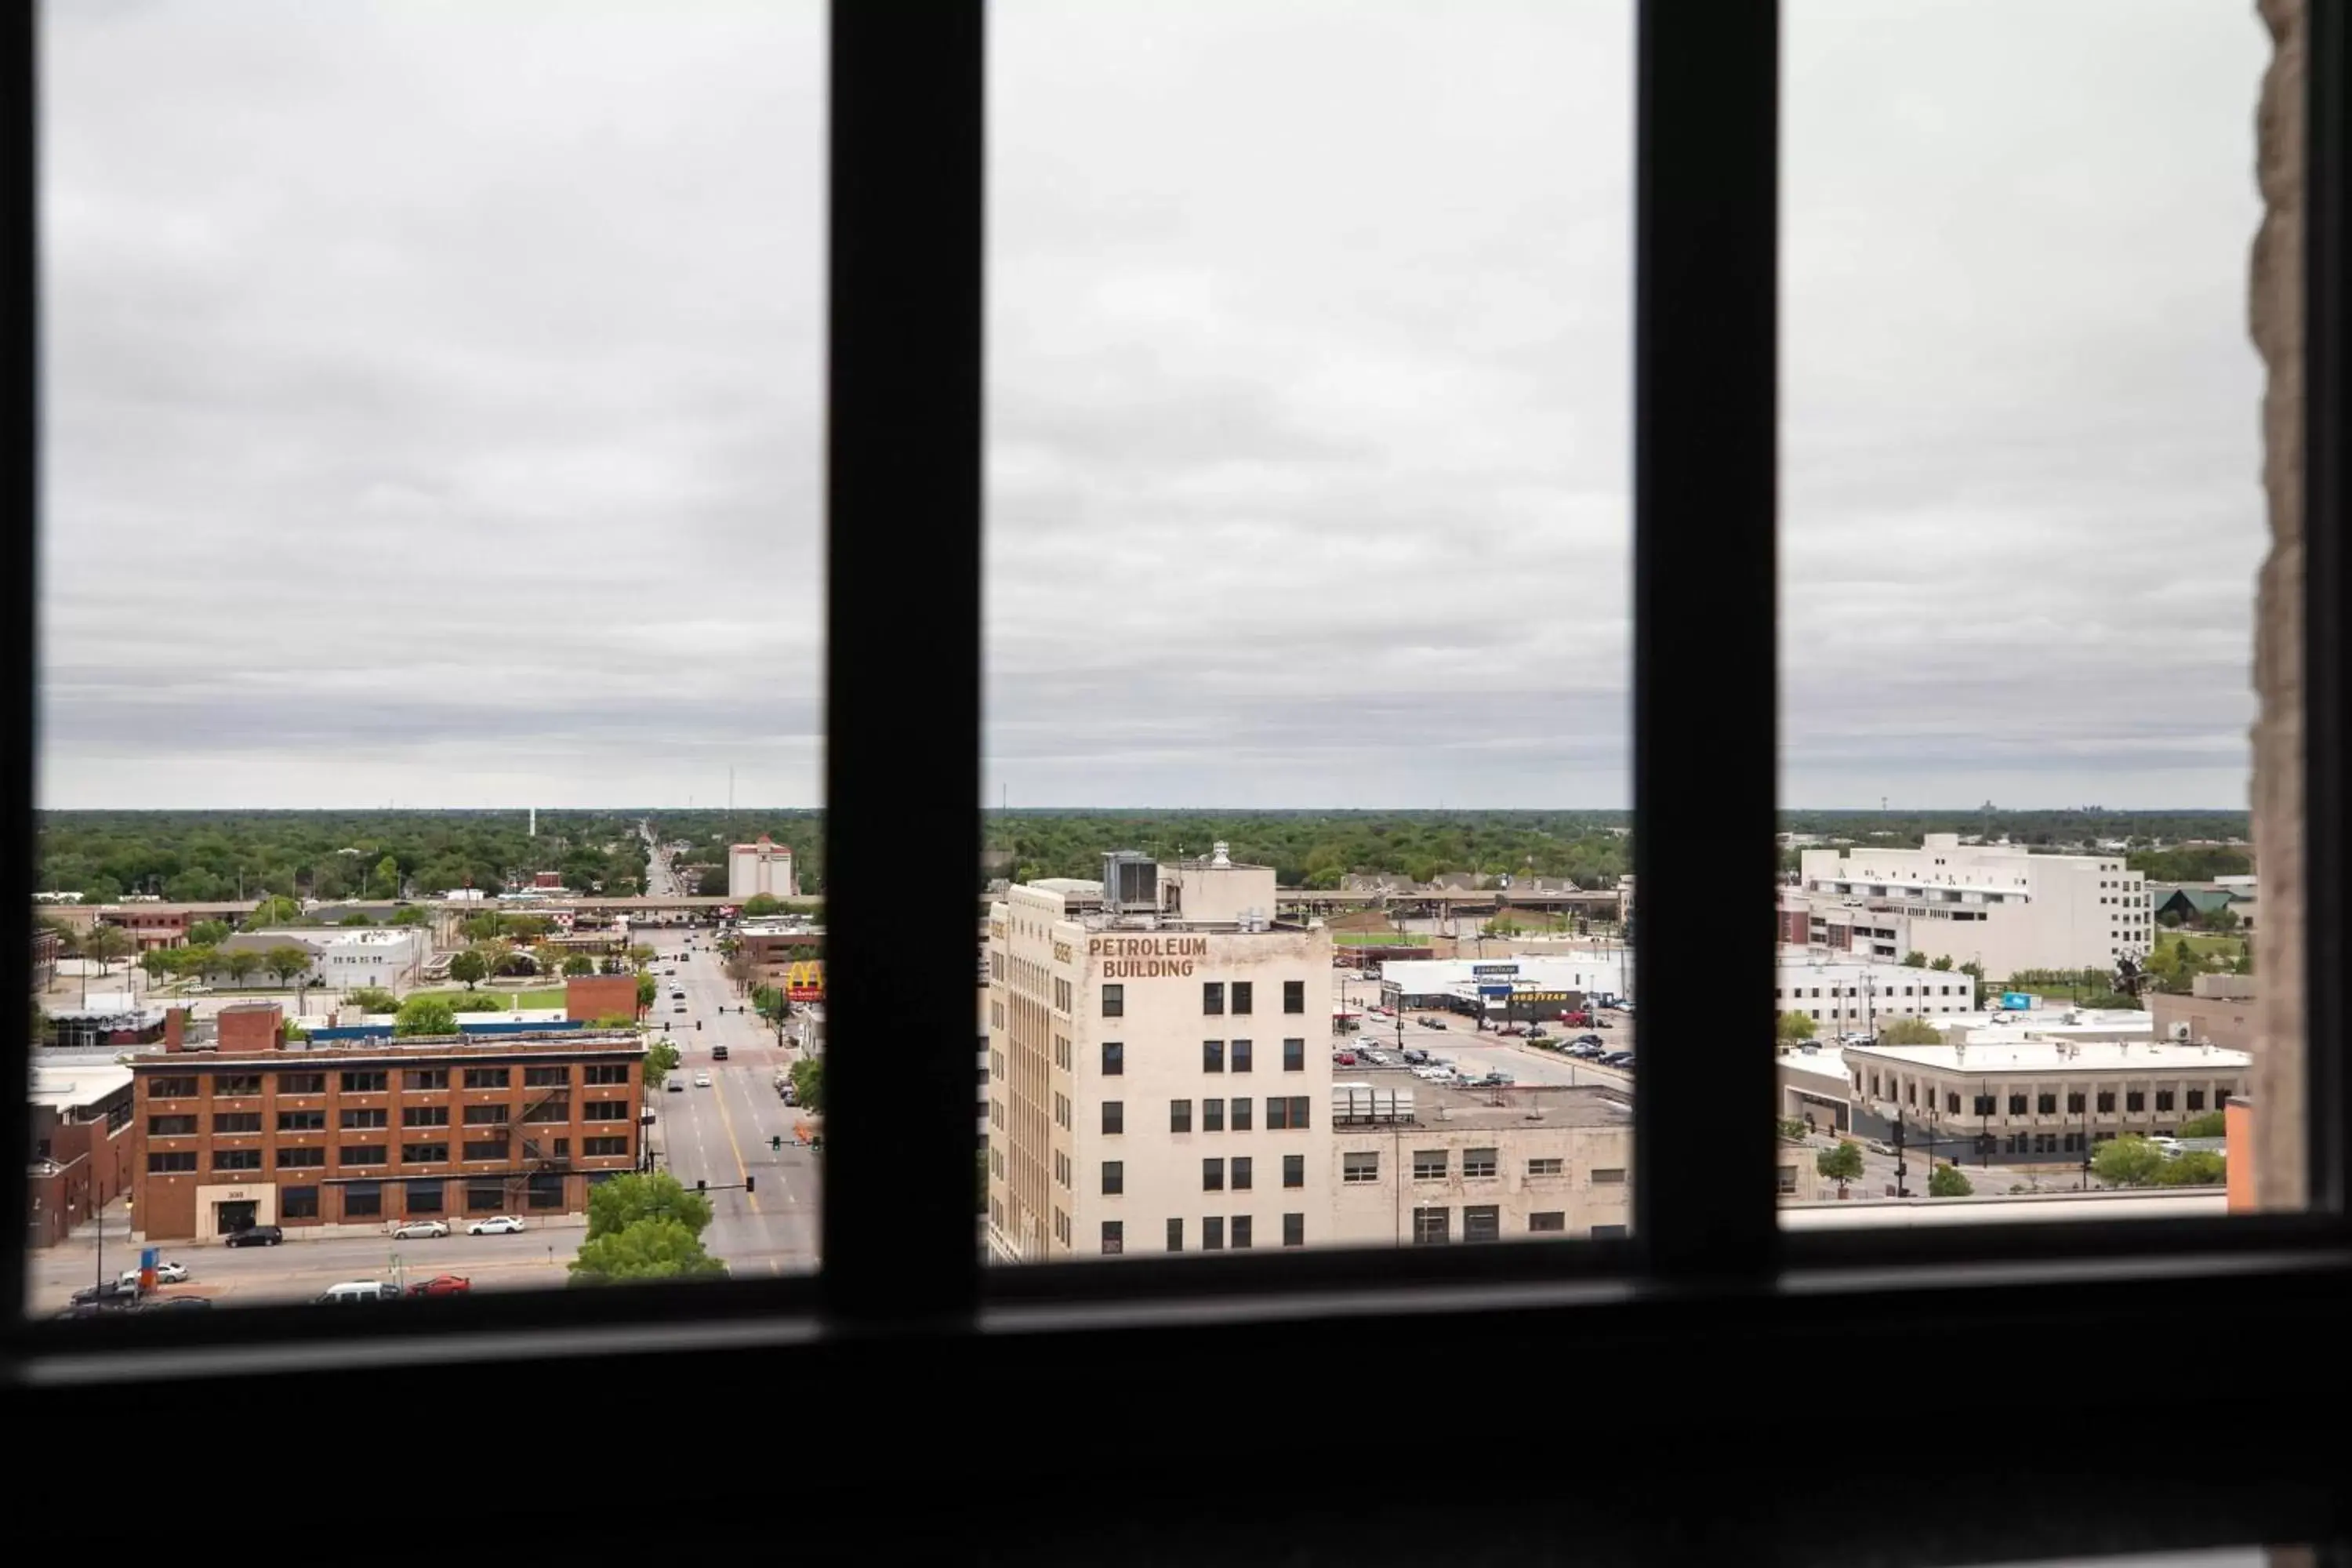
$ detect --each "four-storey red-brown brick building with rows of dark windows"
[132,1011,644,1241]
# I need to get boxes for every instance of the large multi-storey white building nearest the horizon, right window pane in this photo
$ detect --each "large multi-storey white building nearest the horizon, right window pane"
[1780,832,2154,975]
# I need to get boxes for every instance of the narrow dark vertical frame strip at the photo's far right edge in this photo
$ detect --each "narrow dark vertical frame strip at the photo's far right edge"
[2303,5,2352,1215]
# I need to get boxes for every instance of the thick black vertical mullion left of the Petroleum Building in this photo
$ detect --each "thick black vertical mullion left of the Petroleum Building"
[823,0,983,1323]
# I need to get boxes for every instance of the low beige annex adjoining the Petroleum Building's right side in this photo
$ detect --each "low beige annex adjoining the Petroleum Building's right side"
[1327,1072,1632,1246]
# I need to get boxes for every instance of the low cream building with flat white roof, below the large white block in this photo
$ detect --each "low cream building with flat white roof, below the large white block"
[1825,1029,2253,1163]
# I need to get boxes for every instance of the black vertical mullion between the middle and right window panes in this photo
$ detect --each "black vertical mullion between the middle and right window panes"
[1632,0,1780,1283]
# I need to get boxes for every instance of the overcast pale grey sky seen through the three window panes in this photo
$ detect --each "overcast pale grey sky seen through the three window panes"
[40,0,2267,808]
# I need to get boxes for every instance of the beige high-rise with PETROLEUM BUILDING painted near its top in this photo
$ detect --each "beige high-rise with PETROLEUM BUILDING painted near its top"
[988,844,1331,1262]
